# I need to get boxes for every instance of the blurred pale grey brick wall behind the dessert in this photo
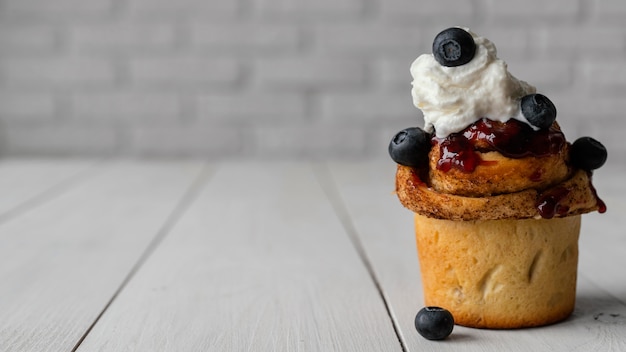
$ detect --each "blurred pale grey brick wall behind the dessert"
[0,0,626,162]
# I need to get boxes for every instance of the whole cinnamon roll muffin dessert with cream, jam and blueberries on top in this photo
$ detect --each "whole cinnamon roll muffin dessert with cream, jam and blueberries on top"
[389,27,607,328]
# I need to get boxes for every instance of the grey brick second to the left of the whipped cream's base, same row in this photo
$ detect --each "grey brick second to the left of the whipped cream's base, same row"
[197,92,306,124]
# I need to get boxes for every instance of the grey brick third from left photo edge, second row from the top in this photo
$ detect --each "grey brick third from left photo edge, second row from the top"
[190,23,301,53]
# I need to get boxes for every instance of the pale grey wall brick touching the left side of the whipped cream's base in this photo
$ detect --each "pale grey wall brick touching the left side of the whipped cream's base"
[321,91,420,126]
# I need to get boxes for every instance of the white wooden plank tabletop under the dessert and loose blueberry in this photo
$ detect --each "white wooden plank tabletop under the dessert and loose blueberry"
[0,159,626,352]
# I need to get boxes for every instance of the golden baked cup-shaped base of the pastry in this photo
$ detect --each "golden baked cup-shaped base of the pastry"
[415,214,580,329]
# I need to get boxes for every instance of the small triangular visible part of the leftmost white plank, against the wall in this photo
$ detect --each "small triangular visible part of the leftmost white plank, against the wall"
[0,159,96,222]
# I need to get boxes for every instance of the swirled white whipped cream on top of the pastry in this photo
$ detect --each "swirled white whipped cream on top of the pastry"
[411,29,536,138]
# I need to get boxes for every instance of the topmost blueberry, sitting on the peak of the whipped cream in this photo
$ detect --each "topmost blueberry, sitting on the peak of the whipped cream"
[433,27,476,67]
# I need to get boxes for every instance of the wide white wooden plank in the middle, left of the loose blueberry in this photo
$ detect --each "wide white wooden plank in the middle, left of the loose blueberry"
[78,162,401,351]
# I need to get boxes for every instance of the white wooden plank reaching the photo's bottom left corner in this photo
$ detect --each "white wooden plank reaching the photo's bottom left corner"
[0,162,202,351]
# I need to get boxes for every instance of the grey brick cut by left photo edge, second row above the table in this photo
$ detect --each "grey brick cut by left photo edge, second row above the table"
[0,91,56,120]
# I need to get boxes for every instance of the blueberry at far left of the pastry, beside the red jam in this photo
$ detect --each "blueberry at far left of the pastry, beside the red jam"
[389,127,431,167]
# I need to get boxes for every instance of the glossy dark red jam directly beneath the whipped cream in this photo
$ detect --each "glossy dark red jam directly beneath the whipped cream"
[432,118,567,172]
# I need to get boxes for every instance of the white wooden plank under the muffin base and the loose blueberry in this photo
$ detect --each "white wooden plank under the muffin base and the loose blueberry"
[330,162,626,351]
